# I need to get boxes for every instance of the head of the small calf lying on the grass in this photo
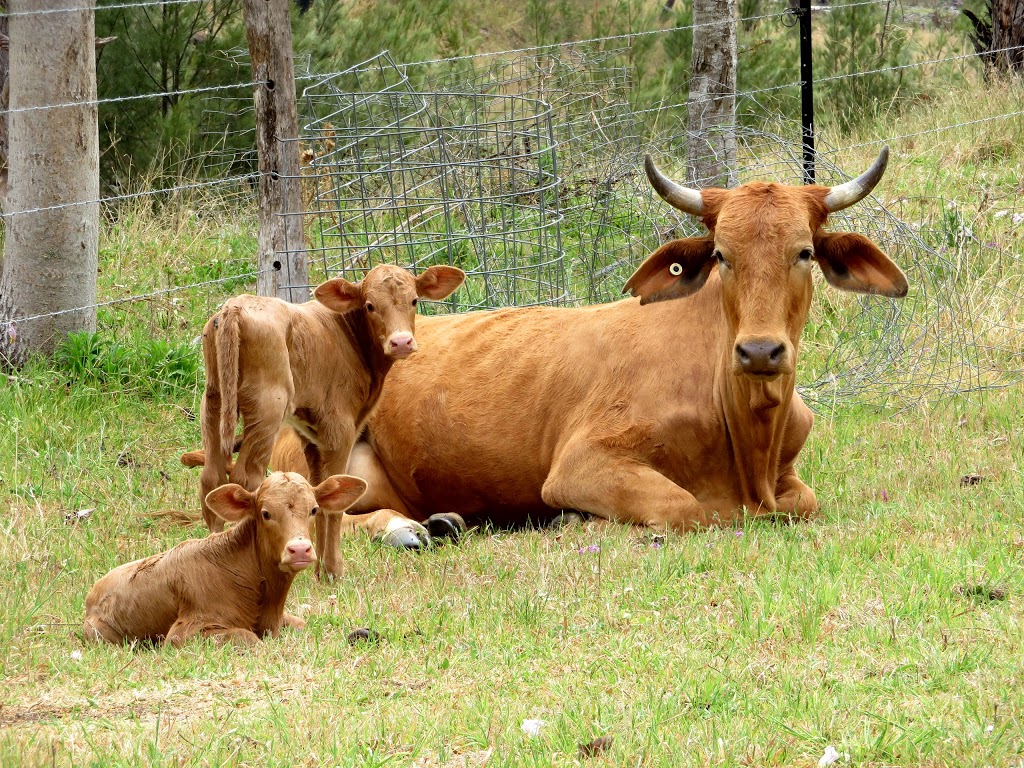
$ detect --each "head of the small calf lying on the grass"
[206,472,367,573]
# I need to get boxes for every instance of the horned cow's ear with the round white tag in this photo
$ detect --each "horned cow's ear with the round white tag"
[623,238,715,304]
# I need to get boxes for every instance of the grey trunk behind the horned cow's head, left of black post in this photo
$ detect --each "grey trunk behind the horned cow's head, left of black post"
[686,0,736,186]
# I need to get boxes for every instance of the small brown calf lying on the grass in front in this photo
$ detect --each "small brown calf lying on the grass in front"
[84,472,367,645]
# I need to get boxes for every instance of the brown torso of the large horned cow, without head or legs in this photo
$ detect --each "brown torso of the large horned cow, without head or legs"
[353,288,719,517]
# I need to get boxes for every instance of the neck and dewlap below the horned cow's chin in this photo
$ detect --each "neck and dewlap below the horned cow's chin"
[718,344,796,511]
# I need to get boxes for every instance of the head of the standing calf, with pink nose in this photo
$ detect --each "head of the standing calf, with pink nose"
[313,264,466,359]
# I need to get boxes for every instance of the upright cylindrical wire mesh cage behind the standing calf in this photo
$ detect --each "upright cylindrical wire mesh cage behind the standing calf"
[292,60,568,311]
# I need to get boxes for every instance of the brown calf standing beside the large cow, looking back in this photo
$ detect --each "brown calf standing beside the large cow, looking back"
[200,265,466,573]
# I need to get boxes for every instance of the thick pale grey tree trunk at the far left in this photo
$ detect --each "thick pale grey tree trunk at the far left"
[0,0,99,366]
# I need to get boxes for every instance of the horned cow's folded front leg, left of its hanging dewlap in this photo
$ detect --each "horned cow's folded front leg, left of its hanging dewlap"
[541,440,737,532]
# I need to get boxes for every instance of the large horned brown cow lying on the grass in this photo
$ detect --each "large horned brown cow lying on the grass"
[288,148,907,530]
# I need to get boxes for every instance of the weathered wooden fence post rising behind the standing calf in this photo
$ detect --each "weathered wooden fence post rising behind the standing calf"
[243,0,309,301]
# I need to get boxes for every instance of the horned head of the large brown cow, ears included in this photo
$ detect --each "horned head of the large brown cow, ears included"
[624,147,907,381]
